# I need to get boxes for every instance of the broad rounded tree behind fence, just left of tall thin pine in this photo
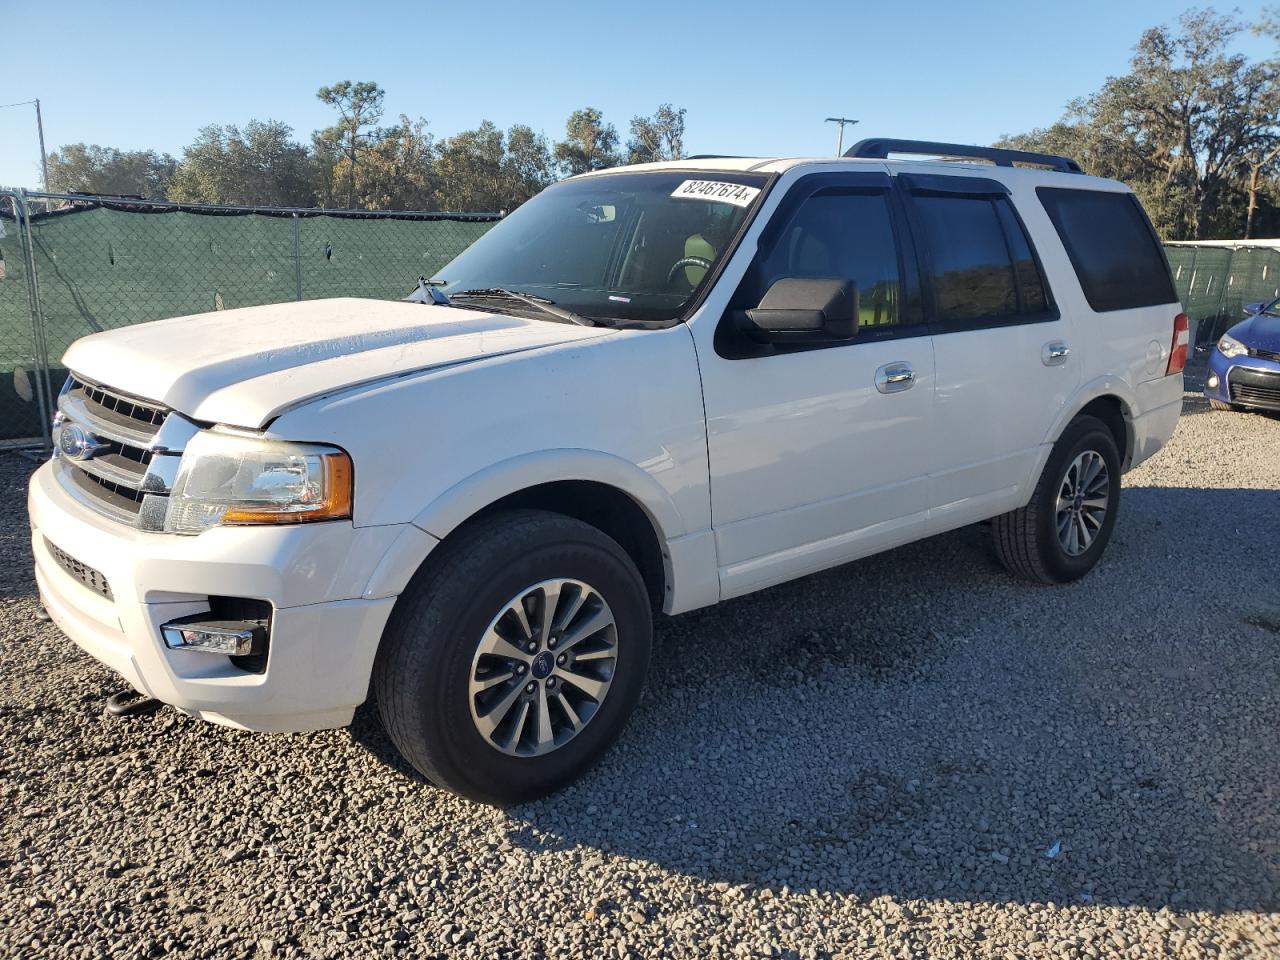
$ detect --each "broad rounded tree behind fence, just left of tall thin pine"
[169,120,319,206]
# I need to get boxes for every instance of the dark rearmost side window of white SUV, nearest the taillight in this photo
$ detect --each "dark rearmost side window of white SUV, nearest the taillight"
[1036,187,1178,314]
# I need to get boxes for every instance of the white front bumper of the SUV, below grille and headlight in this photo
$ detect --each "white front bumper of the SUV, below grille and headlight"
[28,463,403,731]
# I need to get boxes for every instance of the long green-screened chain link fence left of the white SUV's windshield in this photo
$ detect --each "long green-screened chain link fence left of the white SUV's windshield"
[0,189,500,447]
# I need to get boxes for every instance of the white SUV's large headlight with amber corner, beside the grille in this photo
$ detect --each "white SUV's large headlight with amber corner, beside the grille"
[164,430,352,534]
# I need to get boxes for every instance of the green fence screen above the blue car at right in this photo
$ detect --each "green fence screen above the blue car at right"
[1165,241,1280,346]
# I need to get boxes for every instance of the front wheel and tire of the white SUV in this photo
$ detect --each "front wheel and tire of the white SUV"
[374,509,653,805]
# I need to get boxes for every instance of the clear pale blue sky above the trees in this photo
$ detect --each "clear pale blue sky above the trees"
[0,0,1271,187]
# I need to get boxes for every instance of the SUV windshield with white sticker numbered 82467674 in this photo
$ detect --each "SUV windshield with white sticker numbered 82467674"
[436,170,767,323]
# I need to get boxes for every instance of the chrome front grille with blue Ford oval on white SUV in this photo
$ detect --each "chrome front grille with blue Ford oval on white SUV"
[55,374,189,530]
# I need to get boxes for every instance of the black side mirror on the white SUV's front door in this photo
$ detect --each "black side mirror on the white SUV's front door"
[745,276,858,343]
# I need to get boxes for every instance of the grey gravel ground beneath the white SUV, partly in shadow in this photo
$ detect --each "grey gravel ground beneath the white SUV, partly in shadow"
[0,363,1280,957]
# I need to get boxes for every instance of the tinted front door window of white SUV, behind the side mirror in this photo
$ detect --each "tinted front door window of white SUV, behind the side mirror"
[754,188,902,326]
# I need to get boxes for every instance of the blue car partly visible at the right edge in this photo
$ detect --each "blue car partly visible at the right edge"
[1204,297,1280,411]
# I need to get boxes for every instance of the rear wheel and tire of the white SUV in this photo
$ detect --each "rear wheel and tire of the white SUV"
[991,416,1120,584]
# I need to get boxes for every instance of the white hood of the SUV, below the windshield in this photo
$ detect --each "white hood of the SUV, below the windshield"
[63,298,611,428]
